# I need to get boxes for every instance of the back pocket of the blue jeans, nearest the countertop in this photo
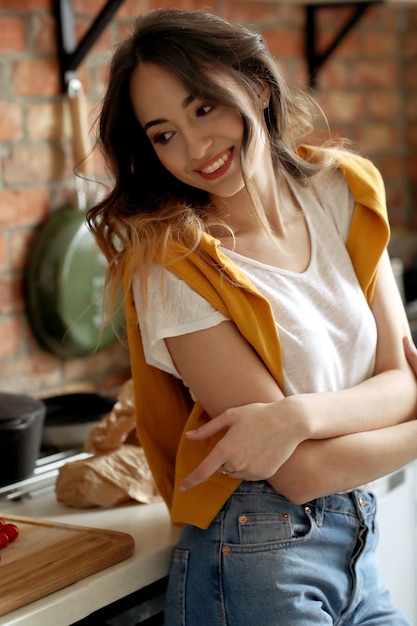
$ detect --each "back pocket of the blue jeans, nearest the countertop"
[164,548,190,626]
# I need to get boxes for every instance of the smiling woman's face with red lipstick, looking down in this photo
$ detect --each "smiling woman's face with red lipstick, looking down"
[130,62,265,198]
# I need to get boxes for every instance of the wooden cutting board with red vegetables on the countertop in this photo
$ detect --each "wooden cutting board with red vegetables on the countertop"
[0,512,135,615]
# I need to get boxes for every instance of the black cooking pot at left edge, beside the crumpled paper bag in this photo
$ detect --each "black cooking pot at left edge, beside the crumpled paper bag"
[0,393,46,486]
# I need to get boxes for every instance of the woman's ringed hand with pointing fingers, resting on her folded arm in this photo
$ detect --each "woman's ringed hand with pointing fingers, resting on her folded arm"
[180,399,309,491]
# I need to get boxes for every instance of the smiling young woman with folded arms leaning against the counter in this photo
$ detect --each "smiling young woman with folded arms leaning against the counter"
[88,10,417,626]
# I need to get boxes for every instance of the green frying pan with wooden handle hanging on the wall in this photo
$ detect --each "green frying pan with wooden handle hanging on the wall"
[26,79,120,358]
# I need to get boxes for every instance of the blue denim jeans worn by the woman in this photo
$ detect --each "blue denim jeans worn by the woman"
[165,481,410,626]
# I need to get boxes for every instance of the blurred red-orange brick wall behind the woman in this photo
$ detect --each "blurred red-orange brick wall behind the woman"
[0,0,417,393]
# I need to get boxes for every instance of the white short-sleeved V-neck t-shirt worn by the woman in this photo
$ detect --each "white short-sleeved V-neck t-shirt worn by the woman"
[133,171,377,395]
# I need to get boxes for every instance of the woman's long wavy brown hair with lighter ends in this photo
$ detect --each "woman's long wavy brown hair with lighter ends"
[87,9,334,310]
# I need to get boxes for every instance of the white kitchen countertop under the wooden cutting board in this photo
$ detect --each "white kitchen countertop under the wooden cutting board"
[0,488,180,626]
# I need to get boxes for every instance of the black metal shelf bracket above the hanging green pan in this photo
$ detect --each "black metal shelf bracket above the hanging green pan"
[54,0,124,91]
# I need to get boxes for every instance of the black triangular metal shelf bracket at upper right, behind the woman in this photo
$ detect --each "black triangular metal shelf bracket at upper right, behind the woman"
[305,0,376,89]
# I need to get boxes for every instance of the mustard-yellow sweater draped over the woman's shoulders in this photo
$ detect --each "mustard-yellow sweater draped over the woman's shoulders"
[124,146,389,528]
